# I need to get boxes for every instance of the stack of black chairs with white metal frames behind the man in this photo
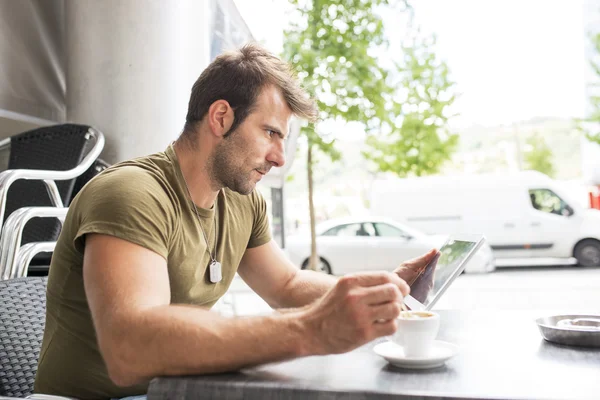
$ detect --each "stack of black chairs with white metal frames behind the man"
[0,124,106,280]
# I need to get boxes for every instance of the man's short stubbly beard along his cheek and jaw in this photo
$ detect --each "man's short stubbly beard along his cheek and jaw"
[209,131,271,195]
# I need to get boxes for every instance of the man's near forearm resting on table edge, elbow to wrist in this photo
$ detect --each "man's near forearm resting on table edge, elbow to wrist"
[99,305,312,386]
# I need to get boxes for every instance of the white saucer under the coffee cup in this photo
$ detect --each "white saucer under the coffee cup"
[373,340,458,369]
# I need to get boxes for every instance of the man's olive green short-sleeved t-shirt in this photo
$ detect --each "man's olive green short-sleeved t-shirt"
[35,146,271,399]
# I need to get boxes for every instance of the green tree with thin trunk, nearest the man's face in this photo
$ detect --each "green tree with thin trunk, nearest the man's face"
[283,0,390,270]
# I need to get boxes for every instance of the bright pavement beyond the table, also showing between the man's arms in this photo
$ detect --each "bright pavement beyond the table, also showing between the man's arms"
[222,266,600,315]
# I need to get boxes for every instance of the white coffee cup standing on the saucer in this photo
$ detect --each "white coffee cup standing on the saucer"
[392,311,440,358]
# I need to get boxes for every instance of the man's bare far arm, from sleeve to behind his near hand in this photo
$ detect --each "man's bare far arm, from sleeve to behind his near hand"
[238,240,338,308]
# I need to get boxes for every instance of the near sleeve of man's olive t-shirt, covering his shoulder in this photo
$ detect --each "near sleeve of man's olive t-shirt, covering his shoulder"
[74,166,173,259]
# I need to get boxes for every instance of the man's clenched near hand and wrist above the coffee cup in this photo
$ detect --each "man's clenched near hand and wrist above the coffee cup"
[304,272,410,354]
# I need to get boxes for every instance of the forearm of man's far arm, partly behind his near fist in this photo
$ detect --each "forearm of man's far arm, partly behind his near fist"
[278,270,338,308]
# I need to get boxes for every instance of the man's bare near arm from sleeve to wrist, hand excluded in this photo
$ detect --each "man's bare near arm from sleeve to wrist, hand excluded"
[83,234,314,386]
